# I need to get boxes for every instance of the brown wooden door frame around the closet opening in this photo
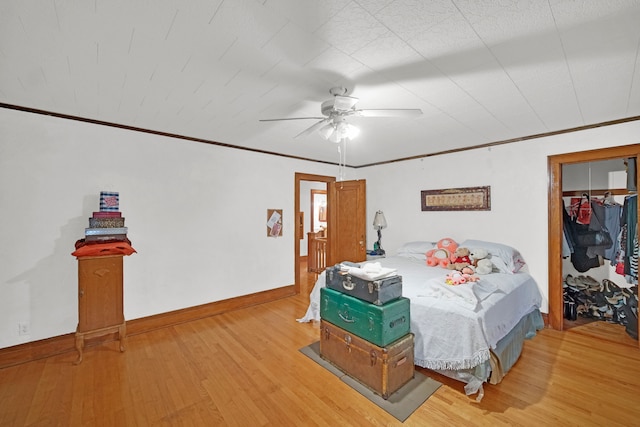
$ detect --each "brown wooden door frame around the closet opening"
[547,144,640,345]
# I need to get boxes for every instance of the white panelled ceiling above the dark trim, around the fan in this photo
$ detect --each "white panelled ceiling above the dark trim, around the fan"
[0,0,640,166]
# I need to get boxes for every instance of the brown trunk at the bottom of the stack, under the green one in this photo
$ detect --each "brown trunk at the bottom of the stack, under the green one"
[320,319,415,399]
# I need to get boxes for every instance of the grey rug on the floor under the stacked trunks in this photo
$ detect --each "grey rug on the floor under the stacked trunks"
[300,341,442,422]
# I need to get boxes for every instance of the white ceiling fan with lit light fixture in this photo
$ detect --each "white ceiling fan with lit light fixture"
[260,87,422,142]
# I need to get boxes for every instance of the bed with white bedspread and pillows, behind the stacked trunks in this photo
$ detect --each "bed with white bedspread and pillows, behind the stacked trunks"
[298,240,543,400]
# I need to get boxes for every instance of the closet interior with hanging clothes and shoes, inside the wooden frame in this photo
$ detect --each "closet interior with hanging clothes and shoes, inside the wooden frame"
[562,158,638,339]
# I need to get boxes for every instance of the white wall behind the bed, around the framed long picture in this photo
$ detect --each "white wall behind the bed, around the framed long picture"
[358,121,640,312]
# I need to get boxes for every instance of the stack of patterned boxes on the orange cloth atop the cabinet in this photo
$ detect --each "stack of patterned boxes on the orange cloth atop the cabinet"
[84,191,127,243]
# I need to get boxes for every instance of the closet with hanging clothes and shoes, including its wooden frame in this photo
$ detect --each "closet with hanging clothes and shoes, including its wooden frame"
[548,145,640,352]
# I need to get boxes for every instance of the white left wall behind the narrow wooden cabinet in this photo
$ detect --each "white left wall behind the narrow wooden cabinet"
[0,109,344,348]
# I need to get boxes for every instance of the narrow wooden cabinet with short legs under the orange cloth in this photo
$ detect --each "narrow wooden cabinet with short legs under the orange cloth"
[75,255,126,364]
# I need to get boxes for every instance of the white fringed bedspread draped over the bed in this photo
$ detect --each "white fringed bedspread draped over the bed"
[298,256,542,370]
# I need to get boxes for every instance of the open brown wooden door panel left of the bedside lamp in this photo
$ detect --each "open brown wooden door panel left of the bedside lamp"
[327,180,367,265]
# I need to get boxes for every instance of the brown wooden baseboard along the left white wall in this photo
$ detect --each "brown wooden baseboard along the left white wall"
[0,285,295,369]
